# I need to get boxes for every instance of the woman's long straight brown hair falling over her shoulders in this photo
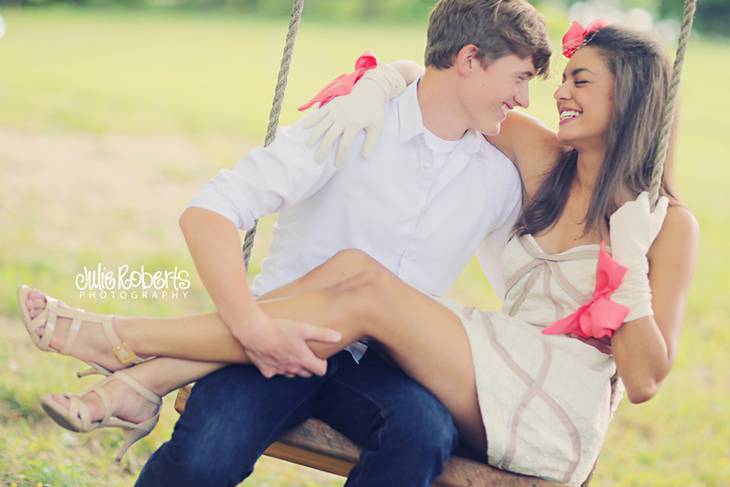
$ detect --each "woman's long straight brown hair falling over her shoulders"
[515,26,674,235]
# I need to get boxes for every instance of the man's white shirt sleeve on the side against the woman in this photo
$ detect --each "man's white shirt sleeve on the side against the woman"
[477,169,522,299]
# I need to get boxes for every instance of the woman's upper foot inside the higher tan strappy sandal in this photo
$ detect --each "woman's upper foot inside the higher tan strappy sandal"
[20,288,141,372]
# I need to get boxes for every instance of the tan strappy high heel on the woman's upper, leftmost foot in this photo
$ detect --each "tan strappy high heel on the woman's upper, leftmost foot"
[18,284,144,377]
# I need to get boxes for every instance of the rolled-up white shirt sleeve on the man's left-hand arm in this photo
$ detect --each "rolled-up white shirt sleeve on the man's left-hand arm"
[186,120,335,230]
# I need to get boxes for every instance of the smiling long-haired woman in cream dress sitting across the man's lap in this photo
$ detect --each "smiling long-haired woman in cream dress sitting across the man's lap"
[14,21,698,485]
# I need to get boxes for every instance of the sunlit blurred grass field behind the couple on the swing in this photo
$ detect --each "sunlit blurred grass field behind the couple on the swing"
[0,9,730,487]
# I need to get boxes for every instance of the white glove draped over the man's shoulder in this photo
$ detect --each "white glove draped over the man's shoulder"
[302,64,406,167]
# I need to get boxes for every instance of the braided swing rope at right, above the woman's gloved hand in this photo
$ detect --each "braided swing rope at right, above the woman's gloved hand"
[649,0,697,208]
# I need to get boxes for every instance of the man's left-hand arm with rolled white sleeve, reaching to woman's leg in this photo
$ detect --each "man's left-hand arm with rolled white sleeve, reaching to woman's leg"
[180,120,339,377]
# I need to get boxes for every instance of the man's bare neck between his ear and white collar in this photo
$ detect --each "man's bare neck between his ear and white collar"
[416,68,469,140]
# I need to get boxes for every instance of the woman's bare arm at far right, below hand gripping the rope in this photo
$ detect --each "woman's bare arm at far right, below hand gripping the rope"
[611,206,699,403]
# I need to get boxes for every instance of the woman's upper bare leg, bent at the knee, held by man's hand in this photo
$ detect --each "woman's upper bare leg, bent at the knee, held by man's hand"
[28,254,486,451]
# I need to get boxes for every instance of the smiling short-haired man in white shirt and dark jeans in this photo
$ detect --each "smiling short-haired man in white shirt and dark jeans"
[137,0,550,487]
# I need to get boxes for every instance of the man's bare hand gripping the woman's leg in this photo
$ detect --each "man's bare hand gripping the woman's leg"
[233,313,342,379]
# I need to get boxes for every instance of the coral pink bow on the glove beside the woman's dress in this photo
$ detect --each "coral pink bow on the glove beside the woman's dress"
[542,242,629,338]
